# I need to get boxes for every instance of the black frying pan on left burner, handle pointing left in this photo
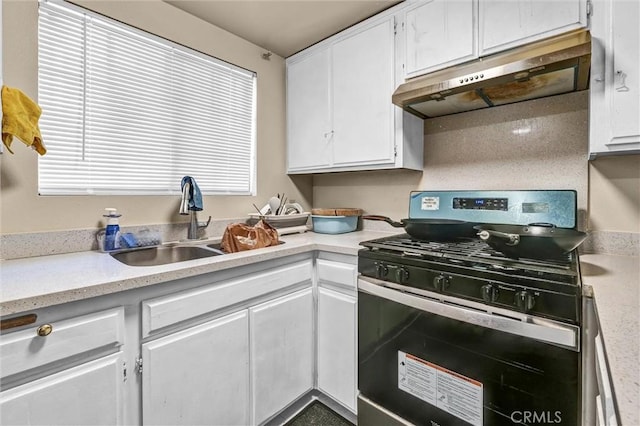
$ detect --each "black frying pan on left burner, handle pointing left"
[362,215,476,240]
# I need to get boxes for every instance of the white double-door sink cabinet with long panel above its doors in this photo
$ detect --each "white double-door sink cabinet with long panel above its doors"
[140,258,314,426]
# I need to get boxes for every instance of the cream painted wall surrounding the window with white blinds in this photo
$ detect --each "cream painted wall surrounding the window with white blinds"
[0,0,312,234]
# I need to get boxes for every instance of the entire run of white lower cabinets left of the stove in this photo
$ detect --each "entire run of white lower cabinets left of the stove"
[0,254,357,425]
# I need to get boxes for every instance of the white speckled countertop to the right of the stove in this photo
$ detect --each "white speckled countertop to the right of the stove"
[580,254,640,426]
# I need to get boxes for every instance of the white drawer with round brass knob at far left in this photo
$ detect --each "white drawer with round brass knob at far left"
[0,307,125,377]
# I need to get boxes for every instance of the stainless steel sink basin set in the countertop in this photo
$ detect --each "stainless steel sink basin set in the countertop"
[111,246,224,266]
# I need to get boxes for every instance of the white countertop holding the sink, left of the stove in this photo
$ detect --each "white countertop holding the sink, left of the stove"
[0,231,393,316]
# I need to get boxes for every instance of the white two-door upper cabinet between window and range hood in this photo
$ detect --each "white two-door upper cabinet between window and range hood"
[287,13,423,174]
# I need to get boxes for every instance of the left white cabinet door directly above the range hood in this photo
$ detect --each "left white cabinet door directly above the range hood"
[403,0,477,78]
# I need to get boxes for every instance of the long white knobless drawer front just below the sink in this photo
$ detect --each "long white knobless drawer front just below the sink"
[142,260,312,338]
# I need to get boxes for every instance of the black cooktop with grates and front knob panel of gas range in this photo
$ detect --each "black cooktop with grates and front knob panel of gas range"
[358,234,582,324]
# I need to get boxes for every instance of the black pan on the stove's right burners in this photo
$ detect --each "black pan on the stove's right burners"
[475,223,587,259]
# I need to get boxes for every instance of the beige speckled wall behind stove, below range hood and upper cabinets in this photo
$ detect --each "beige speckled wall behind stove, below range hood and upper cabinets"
[313,92,589,228]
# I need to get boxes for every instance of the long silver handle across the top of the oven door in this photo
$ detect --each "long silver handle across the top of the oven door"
[358,277,580,351]
